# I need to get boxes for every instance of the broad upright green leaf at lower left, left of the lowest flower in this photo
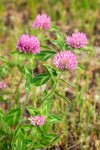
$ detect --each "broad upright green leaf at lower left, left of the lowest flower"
[6,108,21,125]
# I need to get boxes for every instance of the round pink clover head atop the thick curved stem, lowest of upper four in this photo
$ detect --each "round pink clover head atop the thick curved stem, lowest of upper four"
[54,51,77,70]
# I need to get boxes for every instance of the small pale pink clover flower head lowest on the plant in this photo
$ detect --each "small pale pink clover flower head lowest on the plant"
[28,116,45,126]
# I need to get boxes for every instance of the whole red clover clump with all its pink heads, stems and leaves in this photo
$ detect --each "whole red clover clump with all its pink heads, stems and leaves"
[0,14,92,150]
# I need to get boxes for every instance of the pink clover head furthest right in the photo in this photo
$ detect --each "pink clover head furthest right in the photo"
[66,32,87,48]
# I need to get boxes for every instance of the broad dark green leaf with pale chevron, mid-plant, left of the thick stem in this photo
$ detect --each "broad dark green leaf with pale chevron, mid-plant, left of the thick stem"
[32,73,51,86]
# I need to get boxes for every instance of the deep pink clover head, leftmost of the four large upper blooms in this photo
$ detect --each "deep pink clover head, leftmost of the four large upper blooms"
[16,34,40,54]
